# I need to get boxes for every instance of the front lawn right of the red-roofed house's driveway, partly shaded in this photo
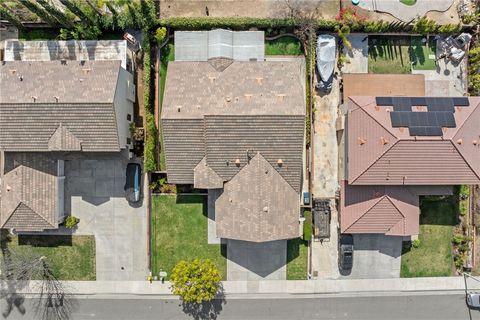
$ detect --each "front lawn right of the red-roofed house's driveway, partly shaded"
[400,199,456,278]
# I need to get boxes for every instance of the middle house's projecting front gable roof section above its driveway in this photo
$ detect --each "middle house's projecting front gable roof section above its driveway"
[215,153,300,242]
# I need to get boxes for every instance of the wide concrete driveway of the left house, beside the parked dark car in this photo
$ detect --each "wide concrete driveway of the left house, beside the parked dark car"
[65,154,148,280]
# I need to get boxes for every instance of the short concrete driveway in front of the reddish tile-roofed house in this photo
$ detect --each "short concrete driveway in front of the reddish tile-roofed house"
[340,234,403,279]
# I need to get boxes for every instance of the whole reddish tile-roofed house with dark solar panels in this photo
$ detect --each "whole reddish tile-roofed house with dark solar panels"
[340,96,480,236]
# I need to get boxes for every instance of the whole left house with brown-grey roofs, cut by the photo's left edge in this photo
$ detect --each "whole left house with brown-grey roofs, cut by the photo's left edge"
[0,60,135,232]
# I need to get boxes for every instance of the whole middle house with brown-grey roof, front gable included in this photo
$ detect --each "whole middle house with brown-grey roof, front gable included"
[161,58,305,242]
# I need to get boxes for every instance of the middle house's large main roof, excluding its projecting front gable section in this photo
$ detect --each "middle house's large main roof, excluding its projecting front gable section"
[162,59,305,192]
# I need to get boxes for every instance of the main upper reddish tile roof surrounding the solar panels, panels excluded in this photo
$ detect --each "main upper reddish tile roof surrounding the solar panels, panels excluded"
[346,97,480,185]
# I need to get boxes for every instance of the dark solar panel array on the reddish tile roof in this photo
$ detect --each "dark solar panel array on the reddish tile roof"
[376,97,470,136]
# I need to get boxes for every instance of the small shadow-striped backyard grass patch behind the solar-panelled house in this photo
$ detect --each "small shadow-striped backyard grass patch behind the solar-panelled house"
[368,36,412,74]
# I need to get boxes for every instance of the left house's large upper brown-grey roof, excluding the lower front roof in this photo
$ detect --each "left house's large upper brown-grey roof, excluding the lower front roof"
[0,61,120,151]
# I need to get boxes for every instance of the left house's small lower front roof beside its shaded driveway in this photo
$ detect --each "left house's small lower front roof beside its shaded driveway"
[0,153,58,231]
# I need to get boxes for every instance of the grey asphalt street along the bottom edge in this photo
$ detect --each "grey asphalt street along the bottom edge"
[6,294,480,320]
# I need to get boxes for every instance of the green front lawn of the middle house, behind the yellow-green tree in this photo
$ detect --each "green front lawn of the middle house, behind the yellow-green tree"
[151,195,227,280]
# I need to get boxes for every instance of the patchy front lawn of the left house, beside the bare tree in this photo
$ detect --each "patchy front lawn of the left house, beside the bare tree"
[2,235,95,280]
